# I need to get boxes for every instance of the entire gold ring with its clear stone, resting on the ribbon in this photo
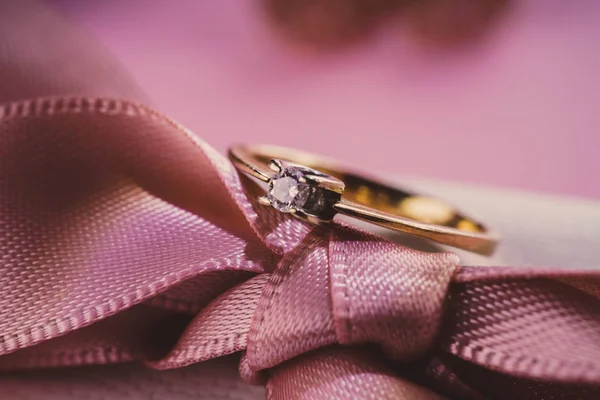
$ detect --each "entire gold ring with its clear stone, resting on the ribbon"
[229,145,498,255]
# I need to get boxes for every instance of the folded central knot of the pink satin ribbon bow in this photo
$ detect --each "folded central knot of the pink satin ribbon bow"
[247,227,458,369]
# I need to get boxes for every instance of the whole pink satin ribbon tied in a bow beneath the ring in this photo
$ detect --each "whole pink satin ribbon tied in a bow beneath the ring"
[0,97,600,399]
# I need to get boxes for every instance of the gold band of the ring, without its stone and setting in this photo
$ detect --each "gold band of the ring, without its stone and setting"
[229,145,498,255]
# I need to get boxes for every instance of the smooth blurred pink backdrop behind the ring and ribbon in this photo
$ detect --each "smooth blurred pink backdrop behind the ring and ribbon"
[48,0,600,197]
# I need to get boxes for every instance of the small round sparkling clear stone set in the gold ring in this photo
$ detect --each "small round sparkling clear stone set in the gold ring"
[267,167,310,212]
